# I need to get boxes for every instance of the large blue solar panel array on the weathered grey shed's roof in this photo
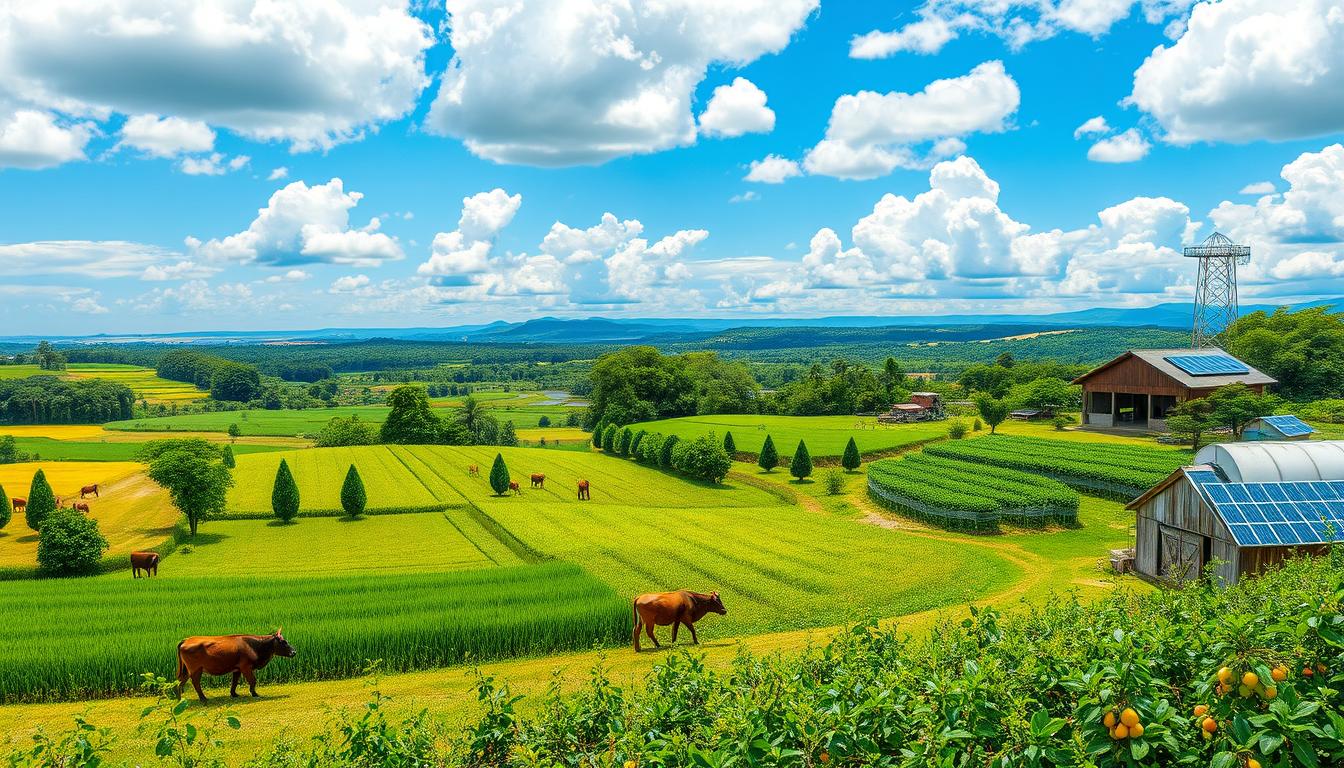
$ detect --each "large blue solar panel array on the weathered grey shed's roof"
[1185,469,1344,546]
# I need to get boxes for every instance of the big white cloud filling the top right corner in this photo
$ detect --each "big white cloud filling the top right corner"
[1129,0,1344,144]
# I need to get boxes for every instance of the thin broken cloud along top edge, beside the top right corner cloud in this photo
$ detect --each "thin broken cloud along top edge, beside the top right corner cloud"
[849,0,1195,59]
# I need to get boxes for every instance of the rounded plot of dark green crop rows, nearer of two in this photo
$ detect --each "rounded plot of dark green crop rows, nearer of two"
[868,453,1078,531]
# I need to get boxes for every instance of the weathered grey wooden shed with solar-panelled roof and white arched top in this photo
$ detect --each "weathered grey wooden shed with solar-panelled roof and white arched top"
[1128,440,1344,584]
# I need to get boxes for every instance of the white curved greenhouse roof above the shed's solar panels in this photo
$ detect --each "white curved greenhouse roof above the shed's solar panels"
[1195,440,1344,483]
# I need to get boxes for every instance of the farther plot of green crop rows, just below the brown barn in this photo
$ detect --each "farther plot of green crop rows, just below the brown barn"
[925,436,1188,498]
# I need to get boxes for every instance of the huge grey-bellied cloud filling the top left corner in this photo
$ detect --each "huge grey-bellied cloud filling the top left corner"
[0,0,434,153]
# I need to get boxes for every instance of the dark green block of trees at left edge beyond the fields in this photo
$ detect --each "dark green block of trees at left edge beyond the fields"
[0,375,136,424]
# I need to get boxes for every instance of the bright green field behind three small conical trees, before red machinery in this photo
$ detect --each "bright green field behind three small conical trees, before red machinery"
[630,414,948,456]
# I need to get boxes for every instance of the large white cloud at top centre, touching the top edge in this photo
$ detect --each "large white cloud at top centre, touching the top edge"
[427,0,817,165]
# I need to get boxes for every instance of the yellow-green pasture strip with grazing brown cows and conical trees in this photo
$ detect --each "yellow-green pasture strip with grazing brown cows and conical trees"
[228,445,781,514]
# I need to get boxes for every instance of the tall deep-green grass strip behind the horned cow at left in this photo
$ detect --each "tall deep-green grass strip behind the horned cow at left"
[0,562,629,703]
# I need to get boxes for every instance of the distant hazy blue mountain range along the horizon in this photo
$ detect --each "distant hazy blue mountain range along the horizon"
[0,300,1344,346]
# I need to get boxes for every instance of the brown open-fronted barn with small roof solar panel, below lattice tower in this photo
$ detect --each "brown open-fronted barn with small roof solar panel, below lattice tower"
[1074,347,1277,432]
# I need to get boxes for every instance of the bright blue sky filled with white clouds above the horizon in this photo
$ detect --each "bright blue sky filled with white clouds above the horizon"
[0,0,1344,334]
